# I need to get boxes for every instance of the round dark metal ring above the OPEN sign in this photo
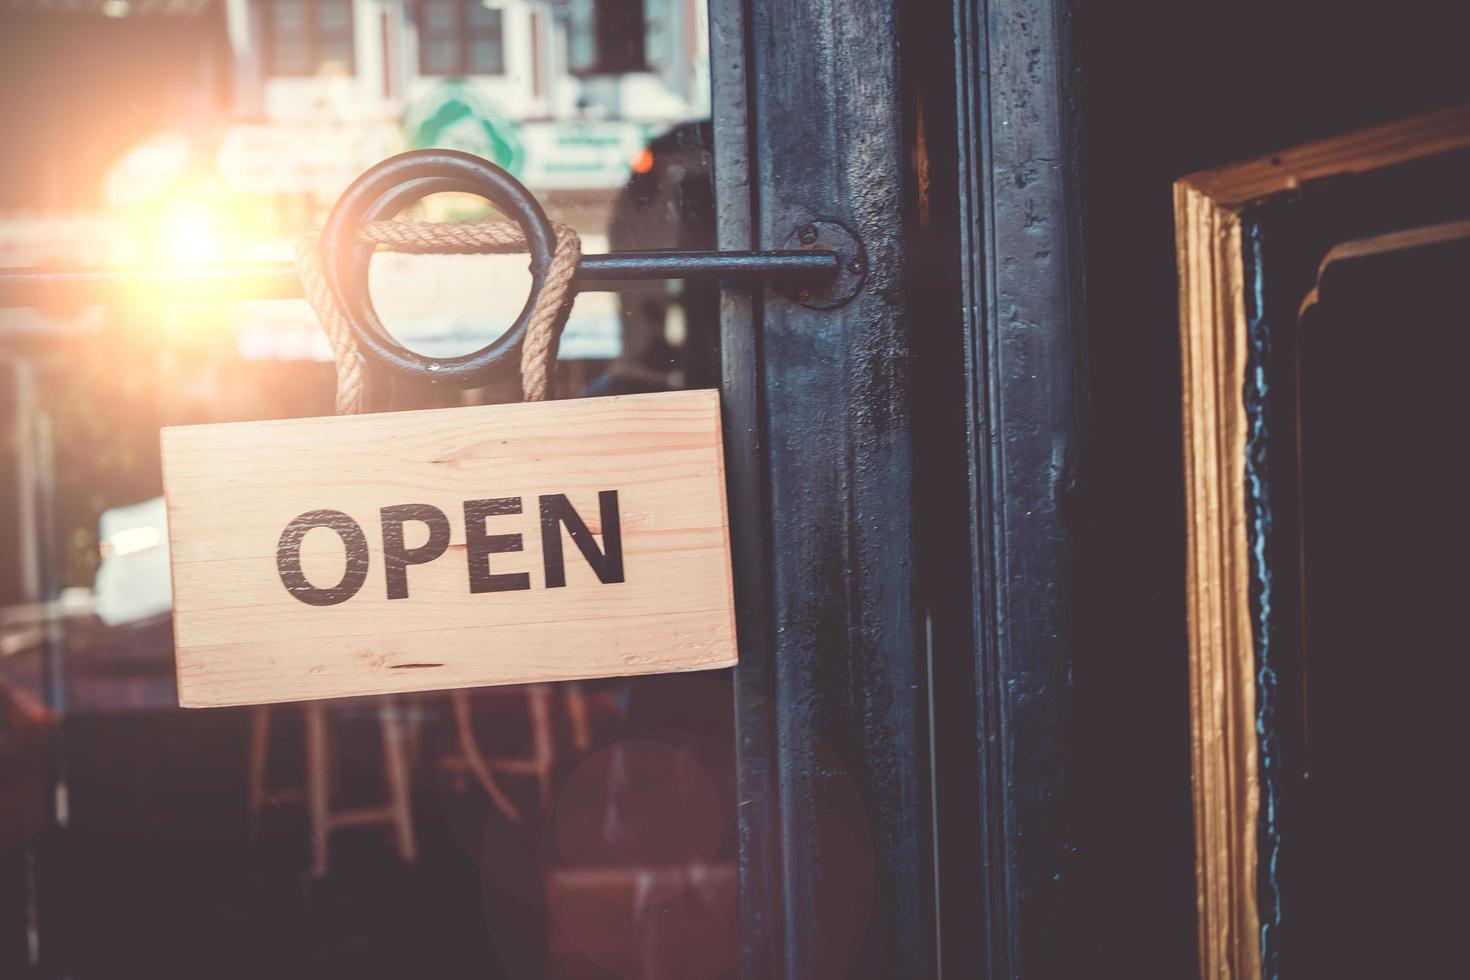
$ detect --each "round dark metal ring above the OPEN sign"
[322,150,556,388]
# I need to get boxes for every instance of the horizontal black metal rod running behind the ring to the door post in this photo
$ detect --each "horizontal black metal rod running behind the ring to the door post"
[0,250,838,307]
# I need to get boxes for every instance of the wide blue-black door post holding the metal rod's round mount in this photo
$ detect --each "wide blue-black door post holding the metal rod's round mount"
[710,0,933,977]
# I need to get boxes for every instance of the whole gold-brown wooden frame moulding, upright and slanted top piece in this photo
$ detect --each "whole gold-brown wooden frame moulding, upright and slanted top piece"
[1175,106,1470,980]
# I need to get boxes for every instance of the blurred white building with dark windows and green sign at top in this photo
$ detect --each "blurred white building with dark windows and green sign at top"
[221,0,710,194]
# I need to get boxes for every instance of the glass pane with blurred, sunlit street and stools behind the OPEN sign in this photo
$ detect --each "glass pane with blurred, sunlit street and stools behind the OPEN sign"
[0,0,736,979]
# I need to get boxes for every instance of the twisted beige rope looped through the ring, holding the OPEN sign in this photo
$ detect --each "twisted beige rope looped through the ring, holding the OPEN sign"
[295,222,582,416]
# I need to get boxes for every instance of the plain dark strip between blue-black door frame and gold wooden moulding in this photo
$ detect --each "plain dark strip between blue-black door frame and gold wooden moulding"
[1061,0,1470,977]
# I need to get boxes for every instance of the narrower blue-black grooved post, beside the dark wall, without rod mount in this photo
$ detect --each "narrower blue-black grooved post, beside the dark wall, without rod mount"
[958,0,1083,977]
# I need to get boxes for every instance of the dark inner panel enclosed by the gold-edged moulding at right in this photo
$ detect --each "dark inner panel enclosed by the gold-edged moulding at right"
[1291,238,1470,977]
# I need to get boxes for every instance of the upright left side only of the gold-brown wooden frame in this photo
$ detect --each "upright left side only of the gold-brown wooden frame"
[1175,181,1261,980]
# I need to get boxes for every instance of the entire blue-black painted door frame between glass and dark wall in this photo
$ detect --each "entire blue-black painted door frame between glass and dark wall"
[710,0,1080,980]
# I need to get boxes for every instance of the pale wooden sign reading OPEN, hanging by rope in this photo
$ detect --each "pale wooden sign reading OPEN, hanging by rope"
[163,391,735,707]
